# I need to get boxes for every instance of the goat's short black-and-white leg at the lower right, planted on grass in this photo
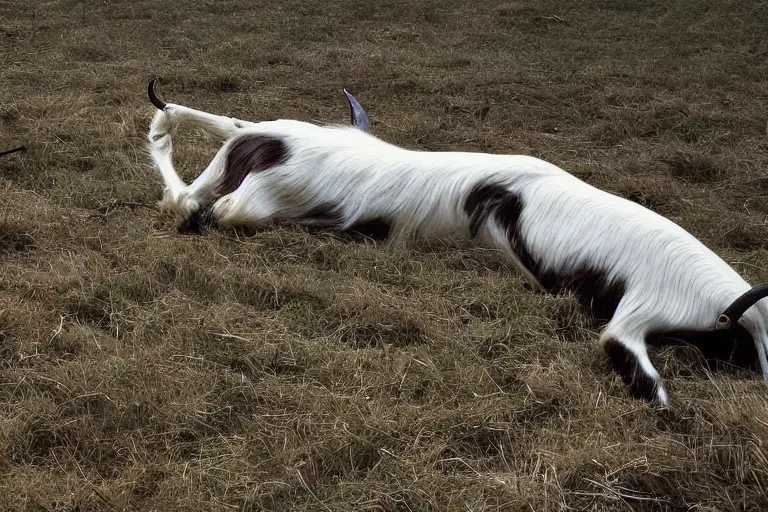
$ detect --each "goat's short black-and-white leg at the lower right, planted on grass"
[600,317,669,407]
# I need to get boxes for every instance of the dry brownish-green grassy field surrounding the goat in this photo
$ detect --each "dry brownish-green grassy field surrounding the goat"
[0,0,768,512]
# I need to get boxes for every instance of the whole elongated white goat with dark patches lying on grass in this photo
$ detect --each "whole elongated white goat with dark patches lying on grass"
[148,82,768,407]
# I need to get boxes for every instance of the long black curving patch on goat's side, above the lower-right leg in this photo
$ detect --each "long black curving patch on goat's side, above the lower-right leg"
[464,183,626,324]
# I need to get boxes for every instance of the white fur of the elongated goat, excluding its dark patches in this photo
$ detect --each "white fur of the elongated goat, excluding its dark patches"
[149,103,768,406]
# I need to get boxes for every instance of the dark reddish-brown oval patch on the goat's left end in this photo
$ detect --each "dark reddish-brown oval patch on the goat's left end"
[224,135,289,197]
